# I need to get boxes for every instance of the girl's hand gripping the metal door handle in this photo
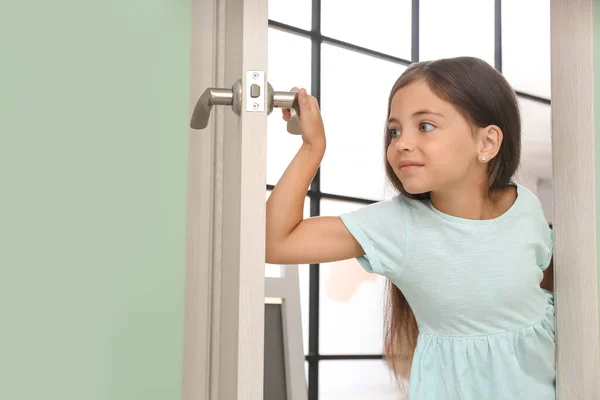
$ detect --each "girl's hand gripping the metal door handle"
[282,87,325,148]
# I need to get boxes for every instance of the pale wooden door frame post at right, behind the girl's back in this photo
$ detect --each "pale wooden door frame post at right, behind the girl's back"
[550,0,600,400]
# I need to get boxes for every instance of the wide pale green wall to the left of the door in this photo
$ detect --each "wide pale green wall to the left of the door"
[0,0,190,400]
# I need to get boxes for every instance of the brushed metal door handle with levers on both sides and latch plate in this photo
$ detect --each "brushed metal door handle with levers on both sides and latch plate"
[190,75,301,135]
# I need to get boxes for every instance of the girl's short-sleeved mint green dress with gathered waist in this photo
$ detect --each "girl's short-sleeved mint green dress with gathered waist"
[340,185,556,400]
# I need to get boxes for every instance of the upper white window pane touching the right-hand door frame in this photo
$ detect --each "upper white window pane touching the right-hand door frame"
[502,0,550,98]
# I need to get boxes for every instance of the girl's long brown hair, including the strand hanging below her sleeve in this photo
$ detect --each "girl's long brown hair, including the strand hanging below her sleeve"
[384,57,521,381]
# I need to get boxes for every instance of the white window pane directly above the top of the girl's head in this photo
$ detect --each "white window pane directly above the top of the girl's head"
[419,0,495,65]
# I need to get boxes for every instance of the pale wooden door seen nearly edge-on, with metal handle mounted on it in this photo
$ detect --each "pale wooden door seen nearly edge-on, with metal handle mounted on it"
[183,0,268,400]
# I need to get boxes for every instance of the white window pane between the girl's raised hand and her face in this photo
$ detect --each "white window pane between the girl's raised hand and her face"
[321,45,405,200]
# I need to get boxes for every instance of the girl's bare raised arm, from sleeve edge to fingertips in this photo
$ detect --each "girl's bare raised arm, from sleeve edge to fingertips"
[265,88,364,264]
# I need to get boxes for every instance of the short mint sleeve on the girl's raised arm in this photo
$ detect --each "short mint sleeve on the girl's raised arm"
[340,196,407,277]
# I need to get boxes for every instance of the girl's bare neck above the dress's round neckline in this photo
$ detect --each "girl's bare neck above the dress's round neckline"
[431,185,517,220]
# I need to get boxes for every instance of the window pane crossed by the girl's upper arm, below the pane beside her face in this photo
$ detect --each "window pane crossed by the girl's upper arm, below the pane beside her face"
[319,199,385,354]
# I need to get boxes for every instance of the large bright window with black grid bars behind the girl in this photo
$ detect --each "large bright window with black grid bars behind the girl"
[267,0,552,400]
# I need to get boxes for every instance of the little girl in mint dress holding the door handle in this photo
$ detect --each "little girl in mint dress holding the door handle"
[266,57,555,400]
